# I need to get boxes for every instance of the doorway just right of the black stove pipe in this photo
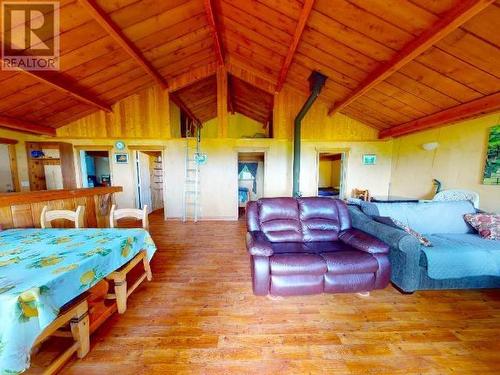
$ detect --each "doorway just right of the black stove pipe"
[318,152,345,199]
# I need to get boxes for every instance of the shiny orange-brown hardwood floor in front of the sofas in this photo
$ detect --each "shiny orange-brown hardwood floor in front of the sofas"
[62,215,500,375]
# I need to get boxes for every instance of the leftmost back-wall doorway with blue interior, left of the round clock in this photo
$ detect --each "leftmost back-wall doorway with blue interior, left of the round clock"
[80,150,111,188]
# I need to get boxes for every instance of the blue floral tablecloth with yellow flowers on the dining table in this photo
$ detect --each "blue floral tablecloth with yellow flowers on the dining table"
[0,228,156,374]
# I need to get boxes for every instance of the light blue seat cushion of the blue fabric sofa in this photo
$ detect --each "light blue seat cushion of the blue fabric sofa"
[419,234,500,279]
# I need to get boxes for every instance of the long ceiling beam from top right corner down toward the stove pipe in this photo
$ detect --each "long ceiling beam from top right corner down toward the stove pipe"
[328,0,494,116]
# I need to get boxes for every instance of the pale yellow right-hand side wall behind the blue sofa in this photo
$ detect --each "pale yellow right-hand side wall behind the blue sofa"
[391,114,500,212]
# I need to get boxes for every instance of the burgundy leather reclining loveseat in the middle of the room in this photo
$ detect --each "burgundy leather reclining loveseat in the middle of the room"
[246,197,390,296]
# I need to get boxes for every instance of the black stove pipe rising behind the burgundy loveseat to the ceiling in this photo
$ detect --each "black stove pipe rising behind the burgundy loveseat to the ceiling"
[293,72,327,197]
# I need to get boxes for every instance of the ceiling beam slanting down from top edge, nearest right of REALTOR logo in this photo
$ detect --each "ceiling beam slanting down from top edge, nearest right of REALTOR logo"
[79,0,168,90]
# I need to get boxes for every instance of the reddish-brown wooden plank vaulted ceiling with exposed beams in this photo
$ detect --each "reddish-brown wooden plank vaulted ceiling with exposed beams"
[0,0,500,137]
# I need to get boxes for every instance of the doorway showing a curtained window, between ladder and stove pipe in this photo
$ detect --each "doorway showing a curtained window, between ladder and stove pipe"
[238,152,265,218]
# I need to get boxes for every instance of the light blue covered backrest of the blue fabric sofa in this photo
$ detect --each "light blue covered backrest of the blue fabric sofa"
[361,201,476,235]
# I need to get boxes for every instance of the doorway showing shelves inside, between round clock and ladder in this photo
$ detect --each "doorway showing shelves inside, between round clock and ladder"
[135,150,164,213]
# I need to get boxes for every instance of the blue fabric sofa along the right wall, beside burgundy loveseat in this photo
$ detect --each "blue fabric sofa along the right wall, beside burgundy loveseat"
[349,201,500,293]
